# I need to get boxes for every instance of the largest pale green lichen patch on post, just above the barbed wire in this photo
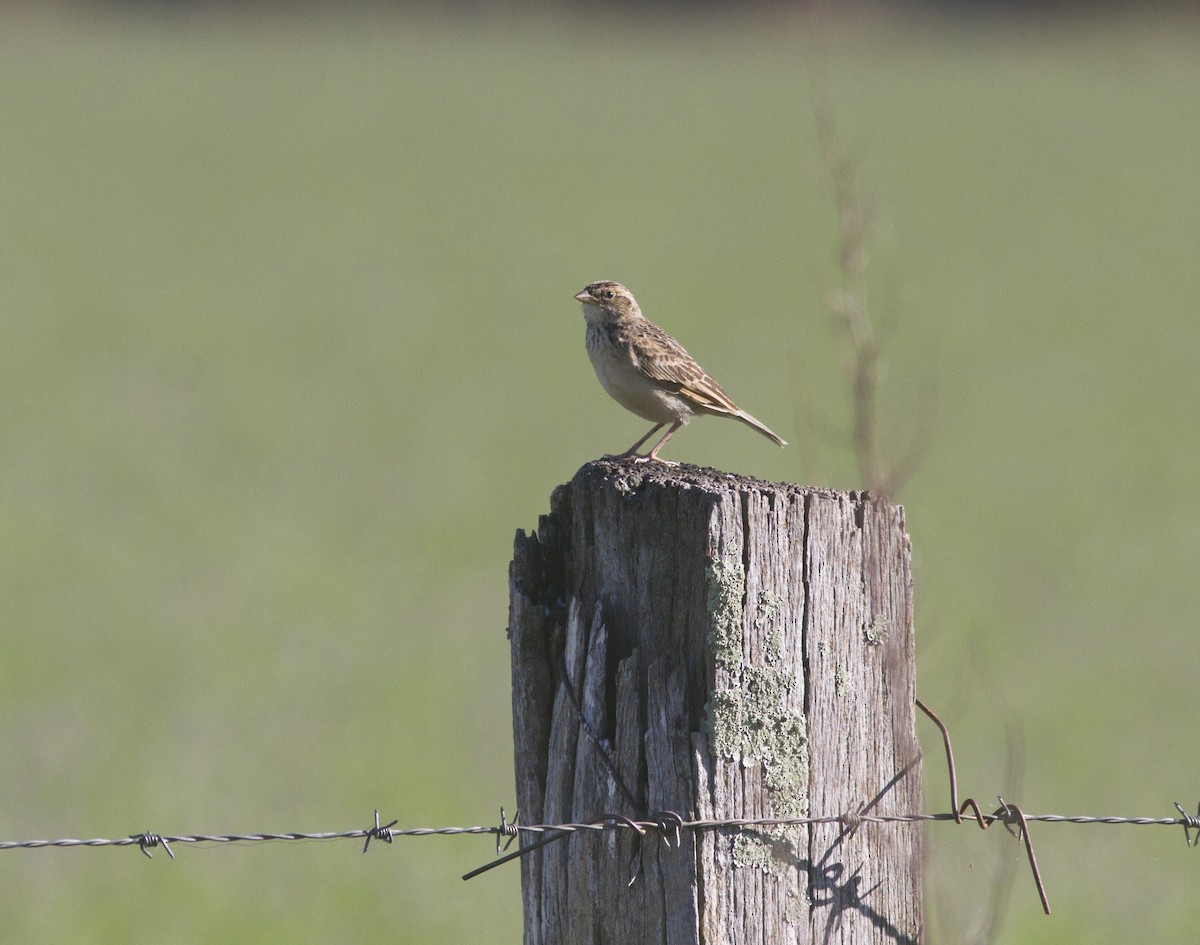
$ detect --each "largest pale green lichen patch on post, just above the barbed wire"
[706,667,809,818]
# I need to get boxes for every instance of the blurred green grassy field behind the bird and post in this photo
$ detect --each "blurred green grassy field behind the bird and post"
[0,7,1200,945]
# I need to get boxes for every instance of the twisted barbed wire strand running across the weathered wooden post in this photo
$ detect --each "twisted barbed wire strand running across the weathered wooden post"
[0,699,1200,915]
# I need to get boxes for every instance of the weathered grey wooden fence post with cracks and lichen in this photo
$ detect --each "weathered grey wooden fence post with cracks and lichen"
[509,461,922,945]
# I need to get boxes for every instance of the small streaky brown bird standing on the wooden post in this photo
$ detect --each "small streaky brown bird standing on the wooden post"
[575,281,787,465]
